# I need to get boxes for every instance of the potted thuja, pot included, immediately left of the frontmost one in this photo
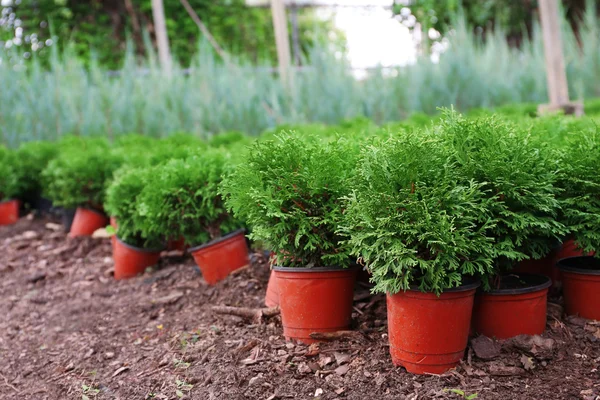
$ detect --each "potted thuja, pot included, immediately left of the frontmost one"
[223,134,357,343]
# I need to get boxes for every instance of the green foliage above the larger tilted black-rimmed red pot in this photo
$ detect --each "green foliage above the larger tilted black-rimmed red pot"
[139,149,241,246]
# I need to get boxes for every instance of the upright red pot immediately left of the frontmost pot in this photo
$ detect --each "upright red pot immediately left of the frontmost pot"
[273,267,357,344]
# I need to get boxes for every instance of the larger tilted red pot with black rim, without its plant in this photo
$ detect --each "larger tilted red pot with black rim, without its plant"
[189,229,250,285]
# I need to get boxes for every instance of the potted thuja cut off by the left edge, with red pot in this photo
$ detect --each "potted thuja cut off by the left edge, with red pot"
[0,145,21,225]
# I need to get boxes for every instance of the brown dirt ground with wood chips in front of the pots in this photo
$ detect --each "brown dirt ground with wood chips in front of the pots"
[0,218,600,400]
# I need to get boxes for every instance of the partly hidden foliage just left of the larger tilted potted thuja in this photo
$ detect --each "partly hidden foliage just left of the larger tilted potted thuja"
[104,166,164,248]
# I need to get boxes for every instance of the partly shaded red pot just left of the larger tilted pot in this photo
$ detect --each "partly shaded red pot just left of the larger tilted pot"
[113,236,160,279]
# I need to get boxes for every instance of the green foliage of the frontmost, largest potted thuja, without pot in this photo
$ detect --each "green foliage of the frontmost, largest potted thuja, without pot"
[340,131,495,294]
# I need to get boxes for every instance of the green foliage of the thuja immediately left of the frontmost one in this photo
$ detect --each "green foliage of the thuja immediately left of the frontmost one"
[222,134,358,267]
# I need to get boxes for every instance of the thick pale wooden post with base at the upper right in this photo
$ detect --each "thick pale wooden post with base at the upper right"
[538,0,583,115]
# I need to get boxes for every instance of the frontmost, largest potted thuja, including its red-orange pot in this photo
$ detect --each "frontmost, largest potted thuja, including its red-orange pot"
[340,132,495,374]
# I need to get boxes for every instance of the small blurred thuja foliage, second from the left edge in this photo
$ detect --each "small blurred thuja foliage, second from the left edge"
[16,141,59,199]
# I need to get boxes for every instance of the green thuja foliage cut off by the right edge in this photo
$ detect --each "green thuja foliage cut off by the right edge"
[557,125,600,256]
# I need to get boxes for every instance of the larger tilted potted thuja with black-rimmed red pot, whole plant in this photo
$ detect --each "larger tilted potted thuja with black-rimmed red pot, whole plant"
[139,149,249,284]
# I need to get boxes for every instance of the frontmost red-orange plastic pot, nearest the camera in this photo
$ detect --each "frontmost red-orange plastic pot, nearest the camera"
[387,282,479,374]
